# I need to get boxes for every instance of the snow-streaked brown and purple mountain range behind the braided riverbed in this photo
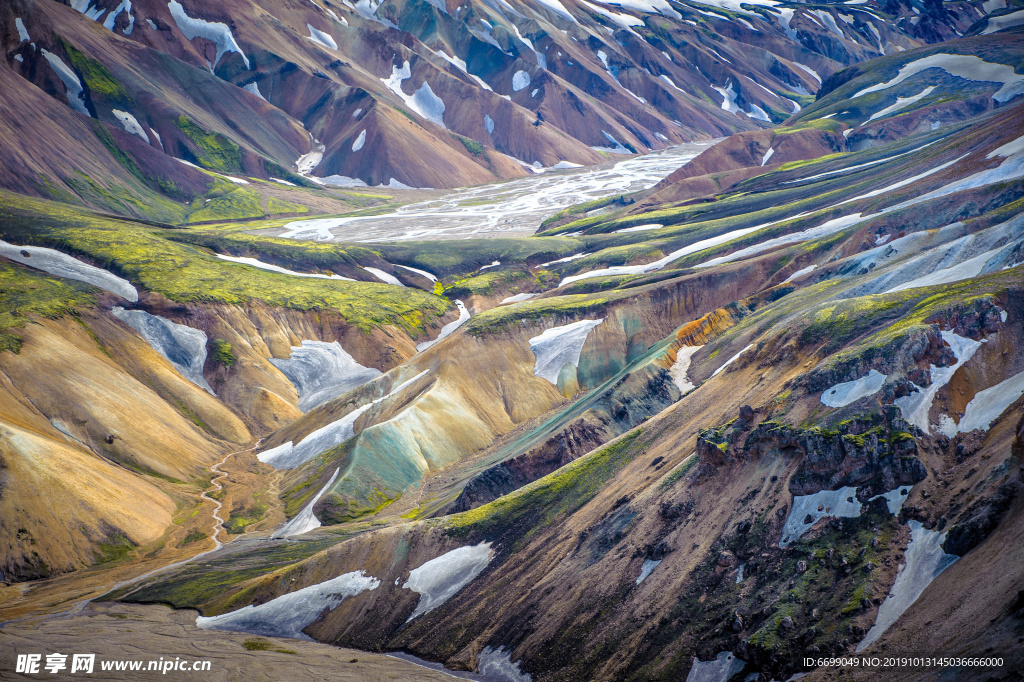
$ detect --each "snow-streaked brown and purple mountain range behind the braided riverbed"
[0,0,1005,206]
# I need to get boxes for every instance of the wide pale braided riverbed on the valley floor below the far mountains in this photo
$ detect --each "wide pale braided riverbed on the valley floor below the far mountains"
[281,140,717,242]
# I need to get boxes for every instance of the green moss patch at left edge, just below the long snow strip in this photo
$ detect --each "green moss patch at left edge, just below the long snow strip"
[0,263,96,353]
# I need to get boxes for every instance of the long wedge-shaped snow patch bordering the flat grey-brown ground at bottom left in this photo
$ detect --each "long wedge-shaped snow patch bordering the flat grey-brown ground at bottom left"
[196,570,381,640]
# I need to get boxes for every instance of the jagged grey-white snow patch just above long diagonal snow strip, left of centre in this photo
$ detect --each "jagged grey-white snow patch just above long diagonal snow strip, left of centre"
[270,339,383,412]
